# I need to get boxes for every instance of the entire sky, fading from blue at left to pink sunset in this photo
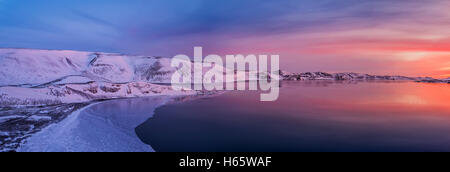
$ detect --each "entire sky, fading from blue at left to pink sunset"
[0,0,450,78]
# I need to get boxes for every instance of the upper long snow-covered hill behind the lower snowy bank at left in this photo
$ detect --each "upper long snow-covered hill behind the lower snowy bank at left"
[0,49,175,86]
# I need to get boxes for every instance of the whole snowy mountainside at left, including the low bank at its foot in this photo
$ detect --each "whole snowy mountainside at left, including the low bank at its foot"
[0,49,196,106]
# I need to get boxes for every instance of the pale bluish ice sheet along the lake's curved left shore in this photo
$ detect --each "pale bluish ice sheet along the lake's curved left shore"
[17,96,173,152]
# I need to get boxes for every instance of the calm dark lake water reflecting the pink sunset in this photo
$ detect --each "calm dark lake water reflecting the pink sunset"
[134,81,450,152]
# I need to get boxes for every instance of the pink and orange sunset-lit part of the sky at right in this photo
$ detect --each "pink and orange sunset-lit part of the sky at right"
[192,2,450,78]
